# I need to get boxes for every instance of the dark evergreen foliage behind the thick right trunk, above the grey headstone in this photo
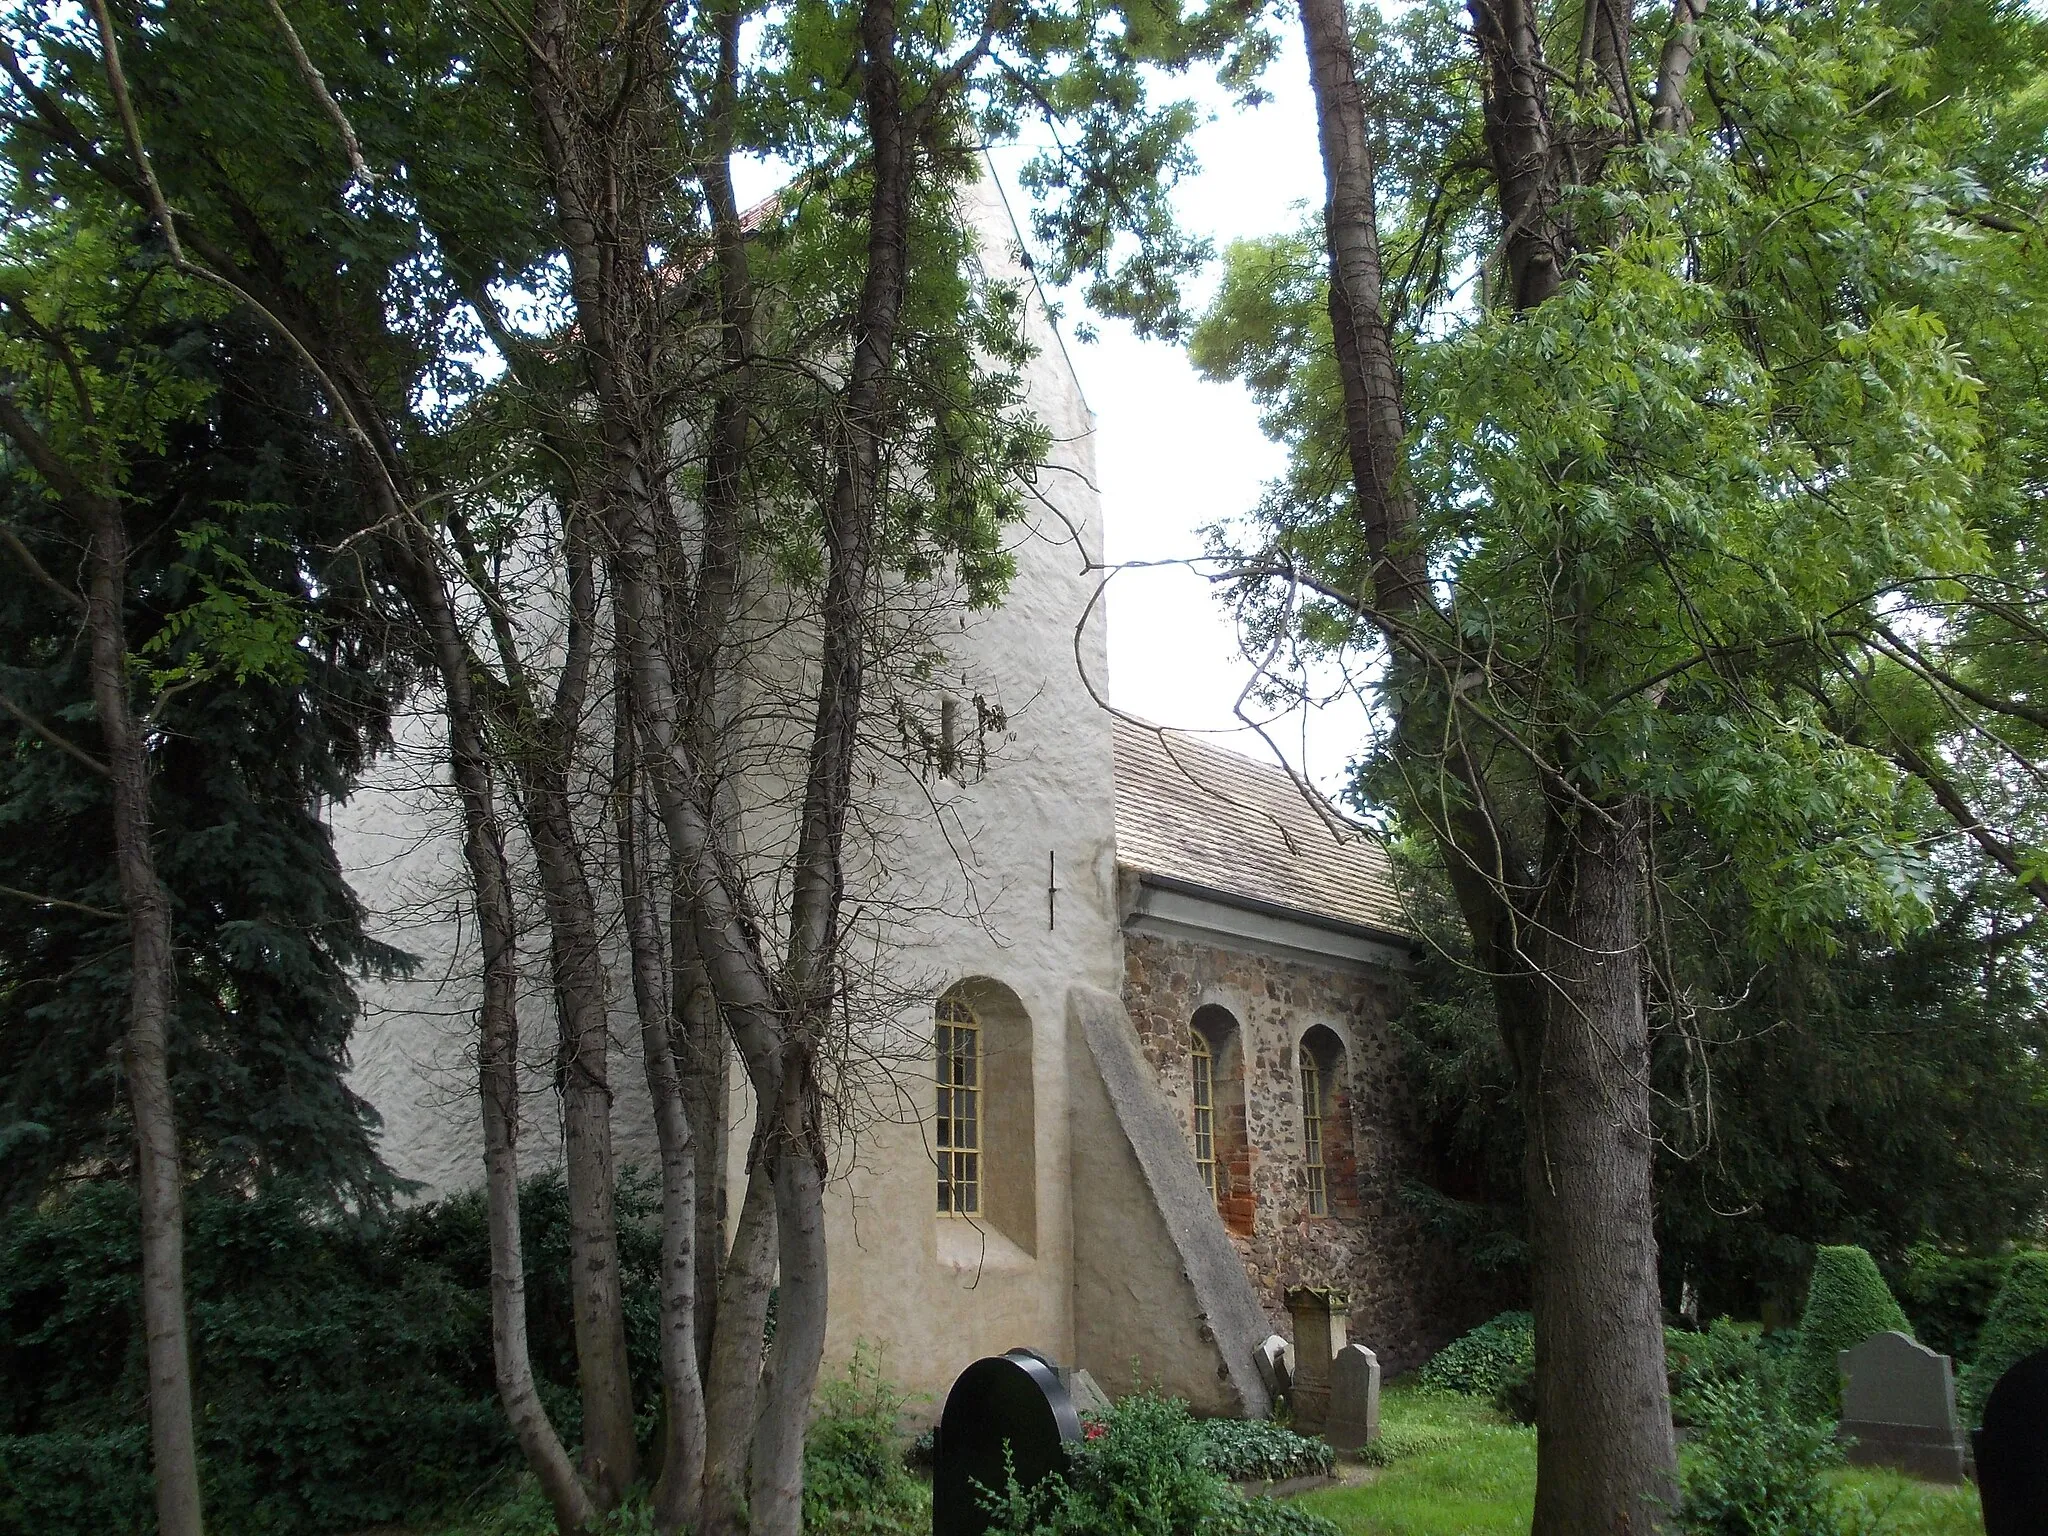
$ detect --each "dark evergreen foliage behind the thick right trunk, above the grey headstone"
[1395,887,2048,1327]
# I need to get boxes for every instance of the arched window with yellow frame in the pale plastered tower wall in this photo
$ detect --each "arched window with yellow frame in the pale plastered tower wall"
[932,977,1038,1253]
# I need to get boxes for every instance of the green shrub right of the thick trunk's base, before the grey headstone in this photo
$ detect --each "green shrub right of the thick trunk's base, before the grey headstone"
[1677,1380,1841,1536]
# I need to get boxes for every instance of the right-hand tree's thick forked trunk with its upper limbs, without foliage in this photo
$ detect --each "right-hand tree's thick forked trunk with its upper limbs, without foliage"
[1300,0,1696,1536]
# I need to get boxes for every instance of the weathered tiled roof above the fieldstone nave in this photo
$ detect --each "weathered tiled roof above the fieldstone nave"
[1116,717,1407,934]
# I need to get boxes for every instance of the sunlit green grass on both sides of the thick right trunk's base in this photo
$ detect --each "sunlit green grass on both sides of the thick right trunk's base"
[1300,1386,1985,1536]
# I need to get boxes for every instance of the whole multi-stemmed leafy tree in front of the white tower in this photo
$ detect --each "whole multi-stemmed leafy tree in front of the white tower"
[10,0,1243,1532]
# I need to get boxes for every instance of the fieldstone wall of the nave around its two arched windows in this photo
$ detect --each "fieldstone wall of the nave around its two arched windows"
[1124,932,1511,1376]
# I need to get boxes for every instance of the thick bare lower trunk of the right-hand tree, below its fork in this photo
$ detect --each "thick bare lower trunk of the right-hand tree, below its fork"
[1503,801,1677,1536]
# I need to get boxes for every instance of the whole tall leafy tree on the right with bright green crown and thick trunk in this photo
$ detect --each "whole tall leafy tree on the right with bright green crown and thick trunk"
[1196,0,2040,1534]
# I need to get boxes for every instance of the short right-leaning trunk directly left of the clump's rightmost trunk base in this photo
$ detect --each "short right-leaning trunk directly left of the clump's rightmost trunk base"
[696,1155,776,1536]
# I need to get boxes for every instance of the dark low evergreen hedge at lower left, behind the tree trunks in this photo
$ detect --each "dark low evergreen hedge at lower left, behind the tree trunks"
[0,1176,659,1536]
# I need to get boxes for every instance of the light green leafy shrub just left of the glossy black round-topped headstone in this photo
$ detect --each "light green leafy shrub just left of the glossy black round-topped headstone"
[803,1343,932,1536]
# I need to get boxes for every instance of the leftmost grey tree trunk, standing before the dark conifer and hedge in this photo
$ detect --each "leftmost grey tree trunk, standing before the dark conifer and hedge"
[86,502,201,1536]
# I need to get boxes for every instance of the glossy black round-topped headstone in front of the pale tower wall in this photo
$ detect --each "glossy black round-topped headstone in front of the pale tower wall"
[932,1350,1081,1536]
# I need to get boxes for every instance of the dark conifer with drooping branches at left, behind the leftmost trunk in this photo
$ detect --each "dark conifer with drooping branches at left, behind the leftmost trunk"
[0,328,403,1202]
